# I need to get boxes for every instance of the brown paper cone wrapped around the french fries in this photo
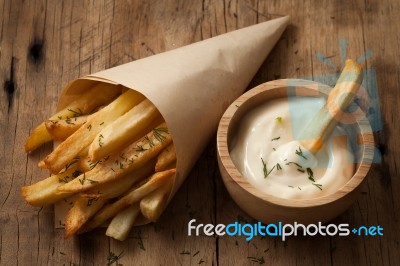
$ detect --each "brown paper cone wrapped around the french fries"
[55,17,289,224]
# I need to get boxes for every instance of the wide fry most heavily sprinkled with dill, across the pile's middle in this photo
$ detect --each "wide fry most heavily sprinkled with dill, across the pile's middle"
[58,123,172,193]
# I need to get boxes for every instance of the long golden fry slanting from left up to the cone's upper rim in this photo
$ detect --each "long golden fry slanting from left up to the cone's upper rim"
[44,90,144,173]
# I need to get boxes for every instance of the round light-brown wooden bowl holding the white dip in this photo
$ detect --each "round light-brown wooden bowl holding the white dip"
[217,79,374,224]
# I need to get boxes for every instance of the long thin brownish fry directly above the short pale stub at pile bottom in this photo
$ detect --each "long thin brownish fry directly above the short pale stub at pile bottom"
[82,169,176,232]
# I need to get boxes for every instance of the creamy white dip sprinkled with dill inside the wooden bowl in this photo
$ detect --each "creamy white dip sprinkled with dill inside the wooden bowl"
[230,97,354,199]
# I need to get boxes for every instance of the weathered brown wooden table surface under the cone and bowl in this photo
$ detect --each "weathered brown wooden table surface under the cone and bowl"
[0,0,400,265]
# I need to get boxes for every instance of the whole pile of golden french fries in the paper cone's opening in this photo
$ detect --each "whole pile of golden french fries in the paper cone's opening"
[21,83,176,241]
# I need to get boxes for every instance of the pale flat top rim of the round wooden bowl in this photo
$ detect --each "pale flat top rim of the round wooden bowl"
[217,79,374,208]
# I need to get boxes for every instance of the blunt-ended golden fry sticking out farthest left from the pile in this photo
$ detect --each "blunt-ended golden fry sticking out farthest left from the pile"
[21,165,80,206]
